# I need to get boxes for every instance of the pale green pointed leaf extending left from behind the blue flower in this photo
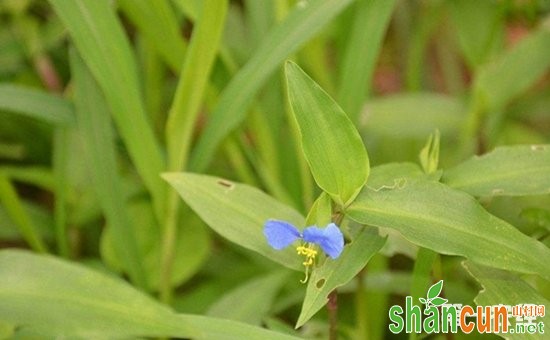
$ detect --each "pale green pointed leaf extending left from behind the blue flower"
[162,173,304,270]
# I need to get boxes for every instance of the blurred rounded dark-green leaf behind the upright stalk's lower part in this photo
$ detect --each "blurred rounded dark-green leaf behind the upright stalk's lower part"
[100,199,210,291]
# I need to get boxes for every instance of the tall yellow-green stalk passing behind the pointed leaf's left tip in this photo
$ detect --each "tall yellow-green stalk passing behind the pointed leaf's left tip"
[160,0,228,303]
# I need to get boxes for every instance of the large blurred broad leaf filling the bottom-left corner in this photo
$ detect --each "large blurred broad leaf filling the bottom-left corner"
[0,250,295,340]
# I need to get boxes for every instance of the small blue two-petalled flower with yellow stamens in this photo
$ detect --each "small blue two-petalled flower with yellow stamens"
[264,220,344,283]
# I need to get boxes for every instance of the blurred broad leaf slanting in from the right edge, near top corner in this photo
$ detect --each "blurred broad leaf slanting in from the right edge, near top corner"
[474,27,550,110]
